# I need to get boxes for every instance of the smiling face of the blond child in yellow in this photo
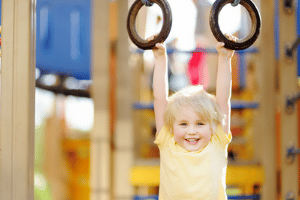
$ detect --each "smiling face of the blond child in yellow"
[173,107,212,151]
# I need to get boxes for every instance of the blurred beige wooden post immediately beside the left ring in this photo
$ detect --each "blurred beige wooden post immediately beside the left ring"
[114,0,134,200]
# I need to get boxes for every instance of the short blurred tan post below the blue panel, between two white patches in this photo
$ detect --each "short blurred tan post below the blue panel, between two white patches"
[43,95,72,199]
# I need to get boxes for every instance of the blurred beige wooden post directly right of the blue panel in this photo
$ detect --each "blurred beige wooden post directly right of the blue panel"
[90,0,112,200]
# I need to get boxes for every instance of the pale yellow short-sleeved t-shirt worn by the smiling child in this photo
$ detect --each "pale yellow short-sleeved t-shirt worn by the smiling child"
[154,126,232,200]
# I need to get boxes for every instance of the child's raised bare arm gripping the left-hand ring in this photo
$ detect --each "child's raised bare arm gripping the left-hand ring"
[153,43,169,133]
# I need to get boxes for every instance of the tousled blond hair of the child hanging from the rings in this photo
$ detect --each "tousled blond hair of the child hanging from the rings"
[164,85,224,133]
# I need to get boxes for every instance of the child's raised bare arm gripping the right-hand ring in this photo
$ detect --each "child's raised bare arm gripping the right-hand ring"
[216,35,237,133]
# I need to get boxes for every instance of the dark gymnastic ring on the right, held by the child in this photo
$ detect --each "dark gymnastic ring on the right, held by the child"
[209,0,261,50]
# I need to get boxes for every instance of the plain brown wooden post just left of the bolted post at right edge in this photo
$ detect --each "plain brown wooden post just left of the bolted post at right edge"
[254,0,276,200]
